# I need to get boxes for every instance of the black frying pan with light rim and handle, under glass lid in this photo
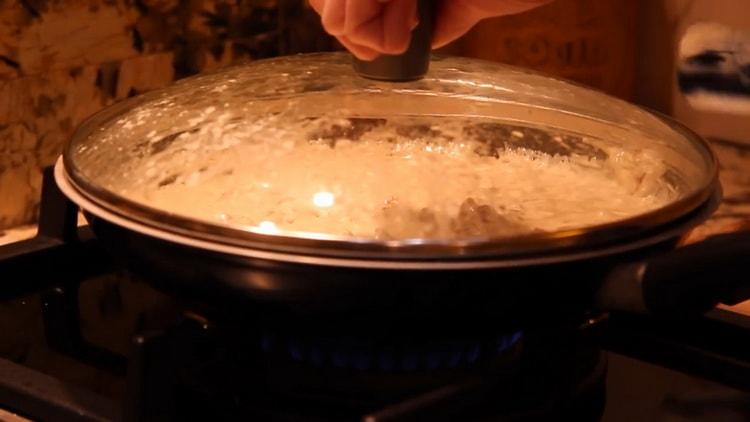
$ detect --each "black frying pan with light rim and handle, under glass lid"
[56,163,750,325]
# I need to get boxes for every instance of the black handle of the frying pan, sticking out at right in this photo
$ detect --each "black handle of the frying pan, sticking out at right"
[596,232,750,317]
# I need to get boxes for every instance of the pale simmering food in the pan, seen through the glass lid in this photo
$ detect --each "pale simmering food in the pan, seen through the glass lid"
[103,116,679,240]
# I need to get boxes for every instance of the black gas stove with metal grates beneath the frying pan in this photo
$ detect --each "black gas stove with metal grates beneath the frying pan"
[0,167,750,422]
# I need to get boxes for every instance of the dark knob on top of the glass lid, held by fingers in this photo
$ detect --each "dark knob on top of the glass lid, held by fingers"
[354,0,435,82]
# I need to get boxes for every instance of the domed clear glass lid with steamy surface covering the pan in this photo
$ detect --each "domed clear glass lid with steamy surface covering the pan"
[64,53,716,255]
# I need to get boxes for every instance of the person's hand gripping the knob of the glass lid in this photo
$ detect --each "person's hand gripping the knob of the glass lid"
[310,0,552,60]
